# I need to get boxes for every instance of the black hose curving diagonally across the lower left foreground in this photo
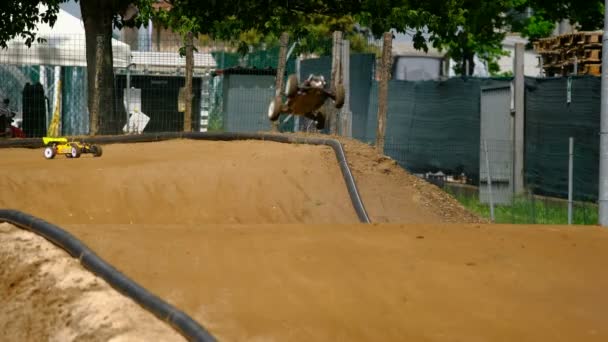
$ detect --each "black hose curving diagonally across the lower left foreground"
[0,209,215,342]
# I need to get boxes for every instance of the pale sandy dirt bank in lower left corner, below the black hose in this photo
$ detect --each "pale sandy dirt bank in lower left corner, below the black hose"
[0,223,185,342]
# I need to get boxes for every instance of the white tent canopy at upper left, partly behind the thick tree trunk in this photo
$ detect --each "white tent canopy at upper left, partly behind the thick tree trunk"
[0,9,131,68]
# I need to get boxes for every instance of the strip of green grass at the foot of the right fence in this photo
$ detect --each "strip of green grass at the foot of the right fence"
[446,189,598,225]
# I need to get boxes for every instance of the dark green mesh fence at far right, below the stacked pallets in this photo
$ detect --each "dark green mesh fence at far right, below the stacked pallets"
[525,77,601,201]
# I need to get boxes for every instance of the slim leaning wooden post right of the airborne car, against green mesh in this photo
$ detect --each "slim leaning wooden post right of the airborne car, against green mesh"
[376,32,393,154]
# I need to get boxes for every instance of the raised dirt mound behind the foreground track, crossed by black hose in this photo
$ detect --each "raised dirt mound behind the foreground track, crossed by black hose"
[0,140,480,224]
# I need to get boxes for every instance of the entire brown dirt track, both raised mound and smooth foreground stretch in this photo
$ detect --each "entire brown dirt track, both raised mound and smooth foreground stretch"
[0,141,608,341]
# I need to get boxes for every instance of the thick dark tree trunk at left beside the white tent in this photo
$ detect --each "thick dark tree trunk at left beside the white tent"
[80,0,119,135]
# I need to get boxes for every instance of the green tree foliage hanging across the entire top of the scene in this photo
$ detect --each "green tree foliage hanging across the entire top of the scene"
[0,0,604,103]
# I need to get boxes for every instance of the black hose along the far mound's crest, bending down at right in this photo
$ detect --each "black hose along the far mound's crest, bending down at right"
[0,132,371,223]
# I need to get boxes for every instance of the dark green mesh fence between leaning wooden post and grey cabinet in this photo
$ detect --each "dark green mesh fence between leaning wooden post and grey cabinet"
[366,78,508,180]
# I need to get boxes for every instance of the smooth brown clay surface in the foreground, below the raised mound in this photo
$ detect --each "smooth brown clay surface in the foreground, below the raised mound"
[67,224,608,342]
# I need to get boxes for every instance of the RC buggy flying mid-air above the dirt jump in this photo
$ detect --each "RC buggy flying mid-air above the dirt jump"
[268,74,344,129]
